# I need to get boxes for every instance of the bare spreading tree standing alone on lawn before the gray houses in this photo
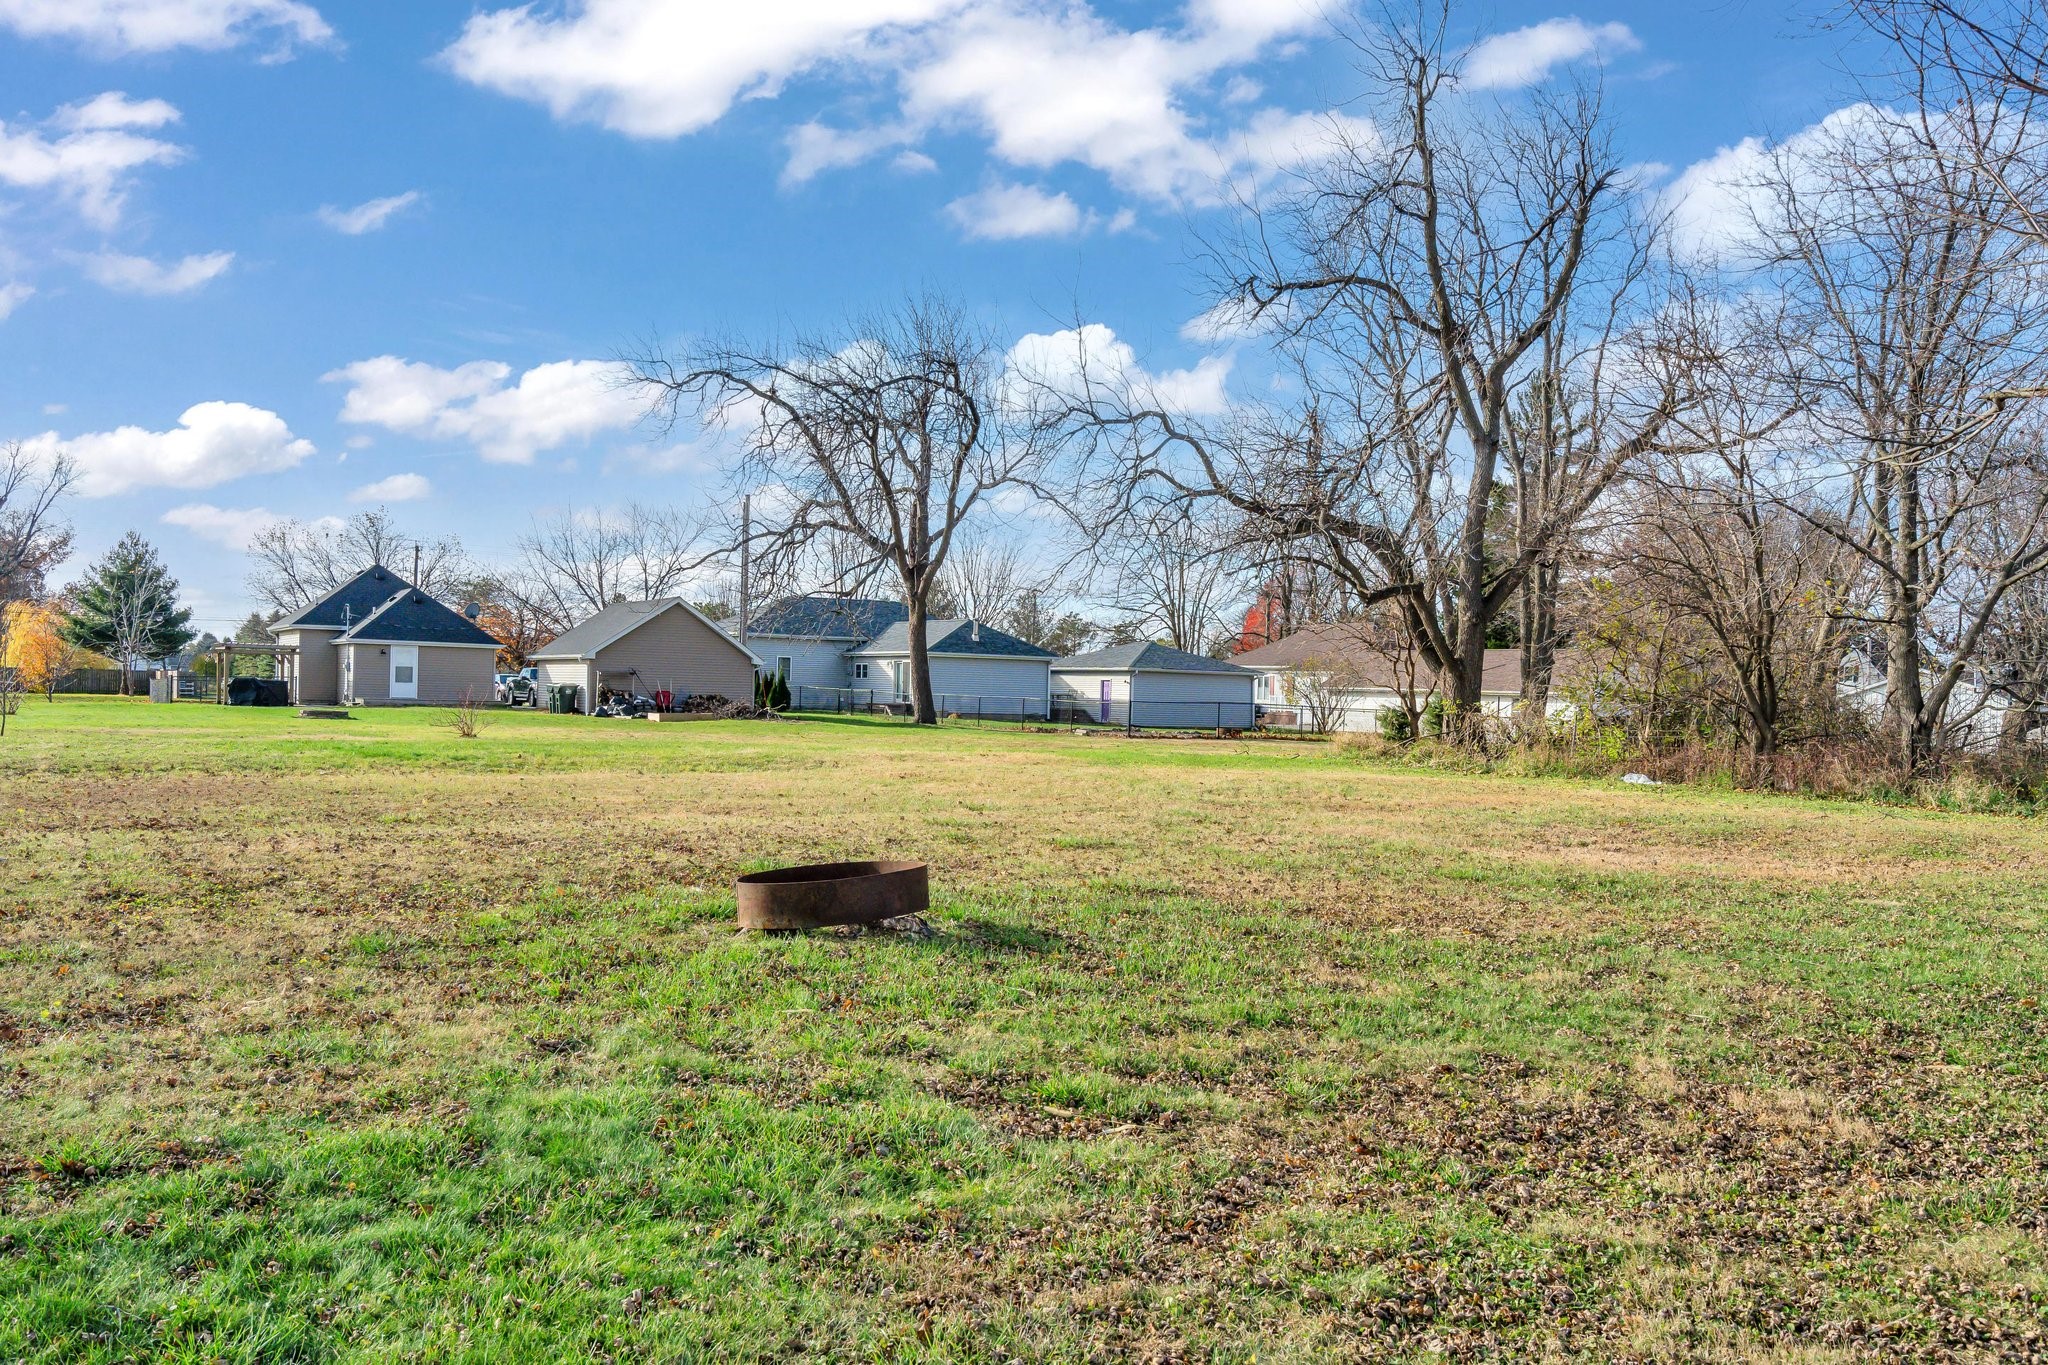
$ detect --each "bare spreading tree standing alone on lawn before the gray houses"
[631,299,1042,724]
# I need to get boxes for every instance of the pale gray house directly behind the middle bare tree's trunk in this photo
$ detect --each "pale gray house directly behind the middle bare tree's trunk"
[846,620,1057,716]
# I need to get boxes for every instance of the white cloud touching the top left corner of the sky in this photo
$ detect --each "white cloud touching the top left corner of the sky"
[0,0,334,53]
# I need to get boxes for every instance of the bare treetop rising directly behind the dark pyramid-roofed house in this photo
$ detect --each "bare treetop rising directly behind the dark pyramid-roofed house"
[248,508,475,614]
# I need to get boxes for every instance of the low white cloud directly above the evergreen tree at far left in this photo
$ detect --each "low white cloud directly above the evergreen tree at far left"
[23,403,313,497]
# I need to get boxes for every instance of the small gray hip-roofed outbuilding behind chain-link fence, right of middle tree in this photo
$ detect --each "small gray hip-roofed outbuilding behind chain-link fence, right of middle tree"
[1053,641,1257,731]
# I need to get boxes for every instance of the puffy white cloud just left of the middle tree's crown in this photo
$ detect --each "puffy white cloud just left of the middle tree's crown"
[324,356,641,465]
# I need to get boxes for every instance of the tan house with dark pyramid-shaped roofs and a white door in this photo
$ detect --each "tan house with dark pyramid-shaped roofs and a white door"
[270,565,498,706]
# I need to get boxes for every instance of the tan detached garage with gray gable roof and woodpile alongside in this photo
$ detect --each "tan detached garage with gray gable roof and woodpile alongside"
[532,598,760,714]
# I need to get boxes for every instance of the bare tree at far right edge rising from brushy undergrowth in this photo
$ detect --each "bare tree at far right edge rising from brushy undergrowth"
[1755,111,2048,767]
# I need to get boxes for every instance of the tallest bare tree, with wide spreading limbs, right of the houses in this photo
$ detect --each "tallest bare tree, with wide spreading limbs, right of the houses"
[1056,0,1683,733]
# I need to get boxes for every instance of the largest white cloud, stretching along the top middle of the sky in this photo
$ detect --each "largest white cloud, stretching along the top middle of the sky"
[442,0,1333,213]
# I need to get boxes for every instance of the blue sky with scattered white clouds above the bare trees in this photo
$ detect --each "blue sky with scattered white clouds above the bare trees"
[0,0,1851,630]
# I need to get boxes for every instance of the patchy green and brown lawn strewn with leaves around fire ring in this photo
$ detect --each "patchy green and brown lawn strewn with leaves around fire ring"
[0,698,2048,1363]
